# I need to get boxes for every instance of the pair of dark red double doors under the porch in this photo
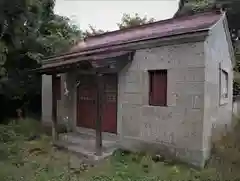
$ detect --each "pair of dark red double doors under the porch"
[77,75,117,133]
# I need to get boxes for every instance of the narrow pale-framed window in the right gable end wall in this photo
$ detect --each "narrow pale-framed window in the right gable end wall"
[219,69,228,103]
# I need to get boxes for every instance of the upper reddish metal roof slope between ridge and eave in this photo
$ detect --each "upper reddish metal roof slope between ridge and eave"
[68,12,222,52]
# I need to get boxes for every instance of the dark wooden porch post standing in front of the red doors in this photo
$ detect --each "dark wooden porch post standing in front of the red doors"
[96,74,103,156]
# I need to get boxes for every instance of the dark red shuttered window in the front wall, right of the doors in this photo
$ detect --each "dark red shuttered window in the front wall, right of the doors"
[149,70,167,106]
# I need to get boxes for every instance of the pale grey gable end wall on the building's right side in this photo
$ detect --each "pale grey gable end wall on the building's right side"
[203,16,233,152]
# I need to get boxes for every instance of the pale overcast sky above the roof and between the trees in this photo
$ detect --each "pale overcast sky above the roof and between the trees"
[54,0,178,31]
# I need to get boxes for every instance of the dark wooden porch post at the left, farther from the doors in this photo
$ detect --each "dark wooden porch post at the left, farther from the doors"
[52,74,58,142]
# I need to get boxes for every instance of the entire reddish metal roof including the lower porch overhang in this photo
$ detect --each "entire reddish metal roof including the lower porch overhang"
[36,12,223,74]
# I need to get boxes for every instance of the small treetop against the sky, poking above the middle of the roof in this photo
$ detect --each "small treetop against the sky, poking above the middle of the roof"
[117,13,155,29]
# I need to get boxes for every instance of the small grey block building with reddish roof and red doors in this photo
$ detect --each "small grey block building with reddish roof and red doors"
[38,12,234,166]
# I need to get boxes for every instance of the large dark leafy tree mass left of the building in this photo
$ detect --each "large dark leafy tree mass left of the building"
[0,0,81,117]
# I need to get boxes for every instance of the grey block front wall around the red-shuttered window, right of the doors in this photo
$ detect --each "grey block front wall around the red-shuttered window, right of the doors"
[118,42,205,165]
